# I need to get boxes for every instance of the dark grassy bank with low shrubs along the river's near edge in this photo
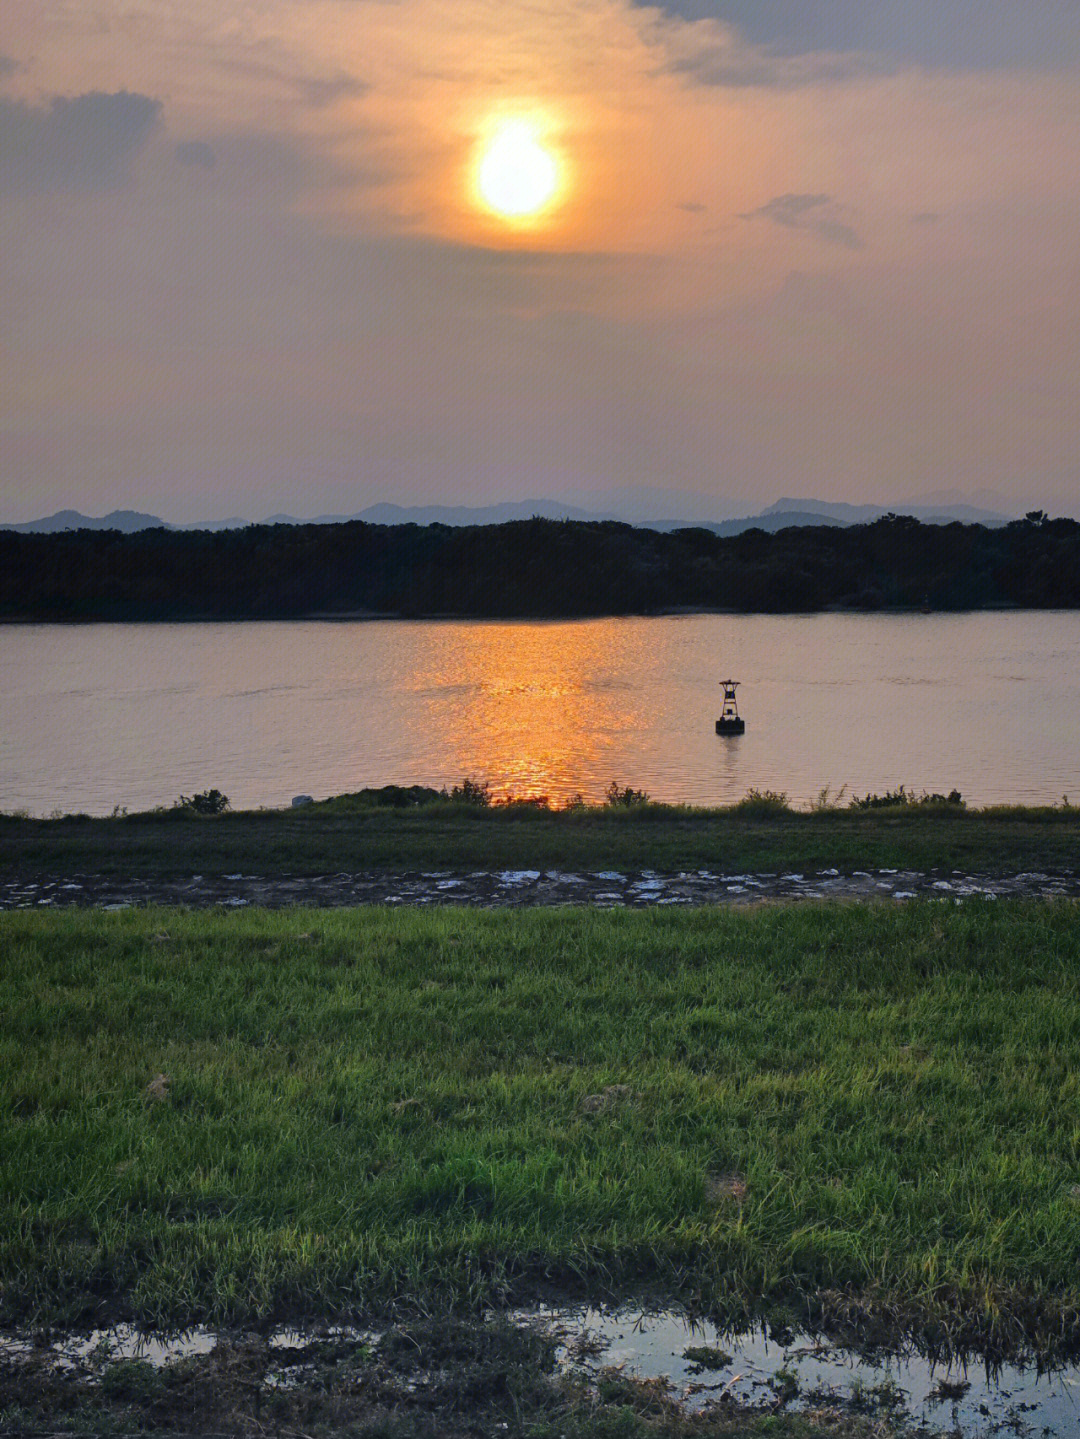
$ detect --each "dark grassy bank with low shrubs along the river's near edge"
[0,796,1080,878]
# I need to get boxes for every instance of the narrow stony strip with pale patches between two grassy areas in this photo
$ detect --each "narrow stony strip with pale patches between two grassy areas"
[0,869,1080,909]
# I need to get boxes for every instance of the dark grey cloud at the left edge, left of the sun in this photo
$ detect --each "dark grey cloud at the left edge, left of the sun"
[0,91,161,194]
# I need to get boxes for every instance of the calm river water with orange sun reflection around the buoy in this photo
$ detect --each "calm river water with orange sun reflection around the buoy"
[0,612,1080,813]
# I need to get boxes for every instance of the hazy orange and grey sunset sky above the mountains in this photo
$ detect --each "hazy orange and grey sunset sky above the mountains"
[0,0,1080,524]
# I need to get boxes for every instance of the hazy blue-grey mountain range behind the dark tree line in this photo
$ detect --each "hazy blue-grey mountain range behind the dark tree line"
[0,498,1012,535]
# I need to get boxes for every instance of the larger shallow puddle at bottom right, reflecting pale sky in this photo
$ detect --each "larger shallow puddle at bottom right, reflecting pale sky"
[512,1305,1080,1439]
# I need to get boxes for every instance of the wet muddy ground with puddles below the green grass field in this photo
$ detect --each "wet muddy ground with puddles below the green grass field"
[0,1305,1080,1439]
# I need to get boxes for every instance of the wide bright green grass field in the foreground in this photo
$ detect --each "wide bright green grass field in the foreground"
[0,901,1080,1348]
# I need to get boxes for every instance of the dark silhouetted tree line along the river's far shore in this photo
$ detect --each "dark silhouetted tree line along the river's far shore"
[0,515,1080,620]
